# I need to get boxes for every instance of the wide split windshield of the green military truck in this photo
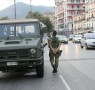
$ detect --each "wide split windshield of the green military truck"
[0,23,38,37]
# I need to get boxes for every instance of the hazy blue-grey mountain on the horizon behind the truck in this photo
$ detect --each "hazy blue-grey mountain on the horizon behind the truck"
[0,2,53,19]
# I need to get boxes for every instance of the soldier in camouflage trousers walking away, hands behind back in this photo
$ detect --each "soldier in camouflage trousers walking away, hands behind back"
[49,31,61,73]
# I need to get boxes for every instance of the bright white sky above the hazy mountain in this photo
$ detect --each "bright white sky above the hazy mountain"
[0,0,54,10]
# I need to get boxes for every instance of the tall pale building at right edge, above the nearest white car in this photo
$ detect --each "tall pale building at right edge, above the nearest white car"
[84,0,95,32]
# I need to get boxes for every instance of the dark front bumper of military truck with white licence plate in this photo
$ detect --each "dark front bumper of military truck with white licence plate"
[0,57,43,71]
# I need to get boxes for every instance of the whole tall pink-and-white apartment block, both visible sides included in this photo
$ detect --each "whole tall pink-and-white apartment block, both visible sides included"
[55,0,85,36]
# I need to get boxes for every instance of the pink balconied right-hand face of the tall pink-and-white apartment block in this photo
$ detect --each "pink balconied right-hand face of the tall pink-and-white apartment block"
[64,0,85,36]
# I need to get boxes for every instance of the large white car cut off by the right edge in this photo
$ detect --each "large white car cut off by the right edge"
[80,33,95,49]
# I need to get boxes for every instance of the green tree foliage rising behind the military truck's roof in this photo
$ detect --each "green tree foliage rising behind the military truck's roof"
[26,11,54,33]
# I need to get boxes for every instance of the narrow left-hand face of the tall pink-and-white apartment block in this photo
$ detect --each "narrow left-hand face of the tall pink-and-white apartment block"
[55,0,64,32]
